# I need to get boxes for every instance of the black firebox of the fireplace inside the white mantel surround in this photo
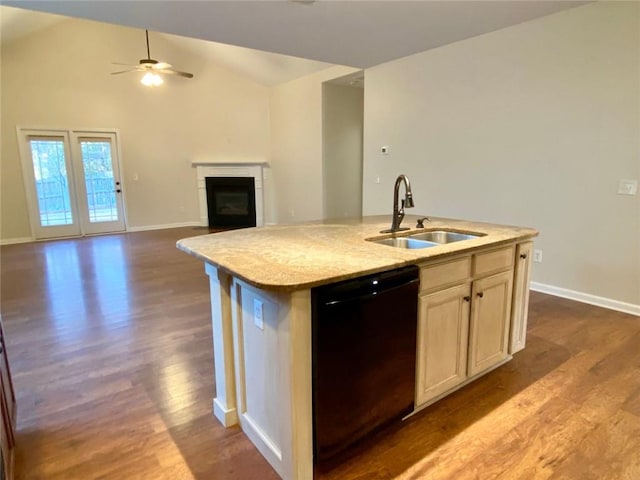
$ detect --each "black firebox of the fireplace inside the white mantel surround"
[205,177,256,228]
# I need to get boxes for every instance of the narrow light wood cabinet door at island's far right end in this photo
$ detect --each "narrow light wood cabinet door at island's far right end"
[509,242,533,353]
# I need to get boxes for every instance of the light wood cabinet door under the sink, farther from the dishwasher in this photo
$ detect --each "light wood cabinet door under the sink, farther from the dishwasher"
[468,271,513,376]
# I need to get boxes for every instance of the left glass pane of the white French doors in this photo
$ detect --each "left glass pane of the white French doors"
[29,139,73,227]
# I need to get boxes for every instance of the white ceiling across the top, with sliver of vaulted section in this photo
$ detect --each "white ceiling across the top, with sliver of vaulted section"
[1,0,589,84]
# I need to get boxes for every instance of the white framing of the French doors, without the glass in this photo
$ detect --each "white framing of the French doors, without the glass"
[16,125,129,240]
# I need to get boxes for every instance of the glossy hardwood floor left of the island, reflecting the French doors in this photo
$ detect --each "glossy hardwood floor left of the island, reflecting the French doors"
[0,228,277,480]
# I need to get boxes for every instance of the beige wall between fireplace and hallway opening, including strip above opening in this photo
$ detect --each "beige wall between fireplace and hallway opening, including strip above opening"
[269,66,357,223]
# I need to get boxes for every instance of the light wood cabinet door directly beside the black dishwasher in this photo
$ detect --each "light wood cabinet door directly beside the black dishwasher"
[416,283,470,406]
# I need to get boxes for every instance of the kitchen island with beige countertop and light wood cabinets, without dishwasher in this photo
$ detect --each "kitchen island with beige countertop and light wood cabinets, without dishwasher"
[177,216,537,480]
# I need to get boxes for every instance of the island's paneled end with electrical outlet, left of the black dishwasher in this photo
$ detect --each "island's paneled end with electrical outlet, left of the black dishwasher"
[232,279,313,480]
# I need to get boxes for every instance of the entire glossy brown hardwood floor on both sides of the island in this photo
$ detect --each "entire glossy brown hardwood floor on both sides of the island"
[0,228,640,480]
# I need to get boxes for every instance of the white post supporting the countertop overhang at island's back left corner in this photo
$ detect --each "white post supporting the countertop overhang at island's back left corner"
[205,263,238,427]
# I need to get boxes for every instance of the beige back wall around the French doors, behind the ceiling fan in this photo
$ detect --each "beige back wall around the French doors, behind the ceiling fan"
[0,20,270,241]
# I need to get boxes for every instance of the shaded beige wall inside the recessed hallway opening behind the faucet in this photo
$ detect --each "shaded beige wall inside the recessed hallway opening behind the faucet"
[322,83,364,218]
